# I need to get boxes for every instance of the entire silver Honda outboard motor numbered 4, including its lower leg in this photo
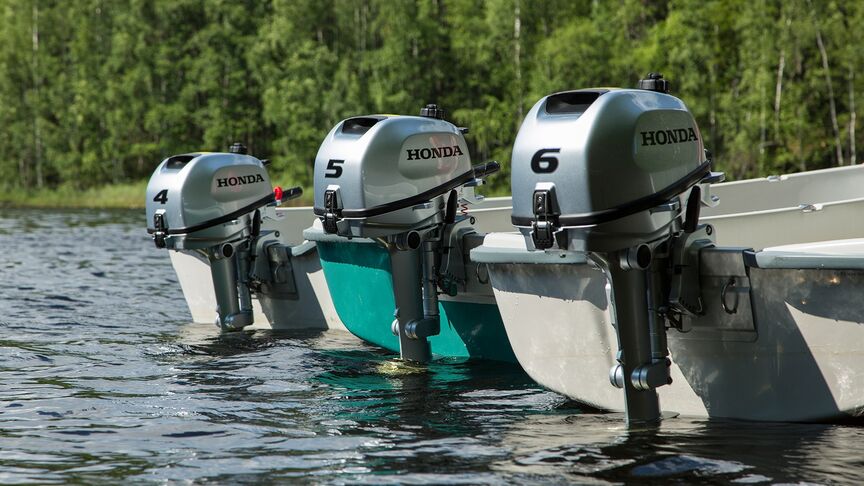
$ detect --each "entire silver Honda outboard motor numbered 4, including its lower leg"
[146,144,302,331]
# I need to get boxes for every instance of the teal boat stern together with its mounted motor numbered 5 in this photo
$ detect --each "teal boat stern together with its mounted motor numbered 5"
[303,105,515,362]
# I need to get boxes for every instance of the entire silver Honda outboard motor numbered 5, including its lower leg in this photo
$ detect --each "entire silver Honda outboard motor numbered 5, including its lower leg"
[315,105,499,362]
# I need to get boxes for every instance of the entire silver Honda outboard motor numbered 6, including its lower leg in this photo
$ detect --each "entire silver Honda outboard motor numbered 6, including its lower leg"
[512,73,723,422]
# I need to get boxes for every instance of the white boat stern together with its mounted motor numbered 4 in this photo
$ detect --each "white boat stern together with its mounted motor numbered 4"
[146,150,352,330]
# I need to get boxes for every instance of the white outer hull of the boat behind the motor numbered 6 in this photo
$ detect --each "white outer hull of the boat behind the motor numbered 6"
[480,235,864,421]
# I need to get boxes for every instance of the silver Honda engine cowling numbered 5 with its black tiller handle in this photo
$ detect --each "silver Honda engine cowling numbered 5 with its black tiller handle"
[315,110,497,237]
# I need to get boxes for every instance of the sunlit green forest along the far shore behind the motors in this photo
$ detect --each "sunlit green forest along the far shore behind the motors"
[0,0,864,205]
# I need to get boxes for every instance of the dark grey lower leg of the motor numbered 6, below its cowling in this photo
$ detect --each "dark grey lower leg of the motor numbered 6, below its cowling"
[597,199,714,423]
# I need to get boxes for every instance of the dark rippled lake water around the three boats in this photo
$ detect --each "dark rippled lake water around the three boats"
[0,210,864,484]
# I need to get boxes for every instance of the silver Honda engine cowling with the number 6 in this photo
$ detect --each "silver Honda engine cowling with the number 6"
[512,82,710,251]
